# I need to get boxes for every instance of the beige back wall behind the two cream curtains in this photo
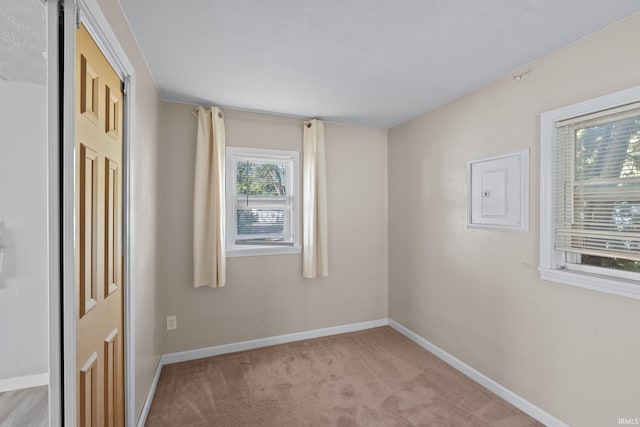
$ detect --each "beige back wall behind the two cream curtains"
[158,103,388,352]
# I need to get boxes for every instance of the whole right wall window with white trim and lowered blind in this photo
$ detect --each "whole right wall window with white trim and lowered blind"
[540,88,640,298]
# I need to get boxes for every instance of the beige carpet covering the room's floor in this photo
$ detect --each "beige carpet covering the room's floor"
[146,327,541,427]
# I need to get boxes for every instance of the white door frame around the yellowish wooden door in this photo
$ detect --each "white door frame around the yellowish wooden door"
[54,0,136,427]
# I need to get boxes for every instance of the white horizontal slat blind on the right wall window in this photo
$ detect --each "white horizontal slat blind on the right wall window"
[553,103,640,261]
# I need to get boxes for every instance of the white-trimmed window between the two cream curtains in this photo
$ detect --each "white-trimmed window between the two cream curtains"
[225,147,300,256]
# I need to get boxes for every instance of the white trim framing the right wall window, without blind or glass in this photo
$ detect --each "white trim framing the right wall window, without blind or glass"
[539,86,640,299]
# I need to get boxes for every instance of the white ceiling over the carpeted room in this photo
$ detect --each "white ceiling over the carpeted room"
[120,0,640,128]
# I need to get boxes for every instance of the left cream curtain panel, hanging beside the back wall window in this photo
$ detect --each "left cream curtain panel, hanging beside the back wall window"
[193,107,226,288]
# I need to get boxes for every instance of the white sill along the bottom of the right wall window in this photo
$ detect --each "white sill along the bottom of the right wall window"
[539,267,640,299]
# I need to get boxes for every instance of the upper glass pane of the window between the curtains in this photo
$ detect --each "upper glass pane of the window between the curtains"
[236,159,287,196]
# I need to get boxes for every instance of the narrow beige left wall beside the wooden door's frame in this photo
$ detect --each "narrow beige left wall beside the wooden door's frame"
[98,0,164,418]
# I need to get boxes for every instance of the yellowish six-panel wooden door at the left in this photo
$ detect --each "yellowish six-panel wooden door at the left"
[75,26,124,427]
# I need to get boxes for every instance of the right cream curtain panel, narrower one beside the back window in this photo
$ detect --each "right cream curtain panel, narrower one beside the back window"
[302,119,329,278]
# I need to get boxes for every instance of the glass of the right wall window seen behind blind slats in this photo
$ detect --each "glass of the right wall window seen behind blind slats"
[561,115,640,271]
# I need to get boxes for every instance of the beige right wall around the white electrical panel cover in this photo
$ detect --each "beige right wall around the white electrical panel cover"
[389,15,640,426]
